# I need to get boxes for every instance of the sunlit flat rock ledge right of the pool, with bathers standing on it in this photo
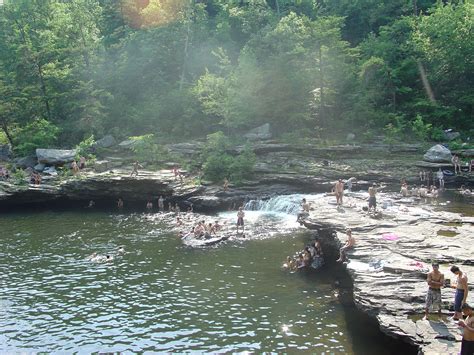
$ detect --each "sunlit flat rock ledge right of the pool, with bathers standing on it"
[305,192,474,354]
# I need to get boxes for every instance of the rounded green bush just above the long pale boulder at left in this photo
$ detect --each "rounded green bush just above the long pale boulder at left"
[13,119,60,156]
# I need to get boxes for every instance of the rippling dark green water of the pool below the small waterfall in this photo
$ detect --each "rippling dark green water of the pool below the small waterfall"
[0,211,386,353]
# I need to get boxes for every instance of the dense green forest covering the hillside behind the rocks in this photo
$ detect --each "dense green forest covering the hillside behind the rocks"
[0,0,474,154]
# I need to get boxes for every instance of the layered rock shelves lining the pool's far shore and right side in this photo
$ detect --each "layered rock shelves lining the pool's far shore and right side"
[0,142,474,354]
